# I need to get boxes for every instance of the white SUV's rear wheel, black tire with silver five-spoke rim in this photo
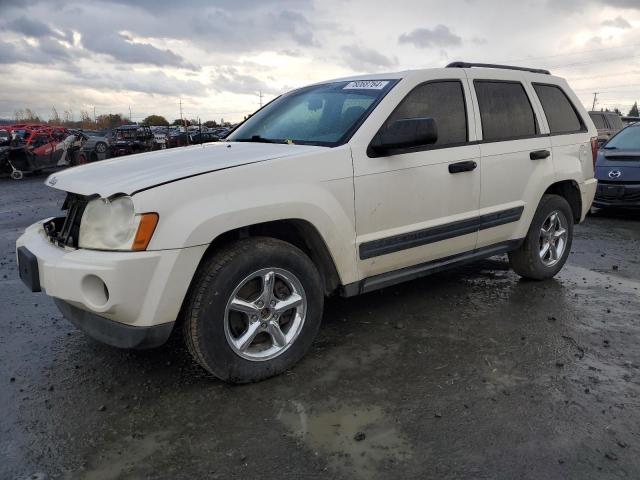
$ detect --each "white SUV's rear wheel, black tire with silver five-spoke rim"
[509,195,573,280]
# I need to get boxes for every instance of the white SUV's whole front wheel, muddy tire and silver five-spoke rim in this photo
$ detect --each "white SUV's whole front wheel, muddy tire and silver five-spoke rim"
[182,237,324,383]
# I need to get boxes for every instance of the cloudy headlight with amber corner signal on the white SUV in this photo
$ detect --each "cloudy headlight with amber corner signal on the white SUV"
[78,196,158,250]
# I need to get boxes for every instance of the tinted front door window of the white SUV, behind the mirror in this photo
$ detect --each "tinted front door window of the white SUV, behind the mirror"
[383,80,467,146]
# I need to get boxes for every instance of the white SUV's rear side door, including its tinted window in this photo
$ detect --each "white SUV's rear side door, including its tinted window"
[468,74,554,248]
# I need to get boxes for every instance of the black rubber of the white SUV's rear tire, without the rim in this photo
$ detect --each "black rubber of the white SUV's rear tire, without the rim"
[509,195,573,280]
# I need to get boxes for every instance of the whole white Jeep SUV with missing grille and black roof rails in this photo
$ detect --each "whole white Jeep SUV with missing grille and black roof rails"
[17,63,597,383]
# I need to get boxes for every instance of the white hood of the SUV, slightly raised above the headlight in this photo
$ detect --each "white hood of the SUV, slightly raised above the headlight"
[45,142,327,198]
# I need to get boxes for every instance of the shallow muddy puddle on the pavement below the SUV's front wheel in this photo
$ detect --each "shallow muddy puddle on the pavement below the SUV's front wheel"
[278,402,412,479]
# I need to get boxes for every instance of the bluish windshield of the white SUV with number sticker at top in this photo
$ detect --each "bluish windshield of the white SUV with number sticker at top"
[227,80,396,147]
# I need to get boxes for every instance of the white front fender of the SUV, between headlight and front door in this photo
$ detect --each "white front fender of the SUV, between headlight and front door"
[134,147,357,283]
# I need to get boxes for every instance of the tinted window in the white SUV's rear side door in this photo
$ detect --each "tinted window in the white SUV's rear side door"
[473,80,539,142]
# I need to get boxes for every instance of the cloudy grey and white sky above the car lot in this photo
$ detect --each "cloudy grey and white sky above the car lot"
[0,0,640,121]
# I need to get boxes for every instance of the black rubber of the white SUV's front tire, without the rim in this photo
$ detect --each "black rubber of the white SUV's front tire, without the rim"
[182,237,324,383]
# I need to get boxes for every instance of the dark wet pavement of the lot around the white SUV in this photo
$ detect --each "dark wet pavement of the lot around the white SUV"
[0,177,640,479]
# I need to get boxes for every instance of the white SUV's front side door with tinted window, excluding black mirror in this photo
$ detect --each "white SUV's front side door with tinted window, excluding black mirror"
[353,71,480,277]
